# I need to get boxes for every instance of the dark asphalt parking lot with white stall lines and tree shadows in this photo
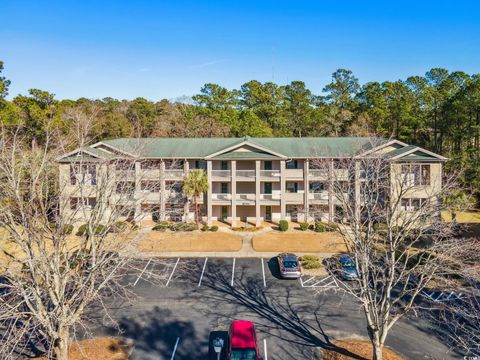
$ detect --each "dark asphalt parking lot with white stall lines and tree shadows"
[95,258,456,360]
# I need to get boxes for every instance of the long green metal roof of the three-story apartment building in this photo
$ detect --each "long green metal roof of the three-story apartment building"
[60,136,444,161]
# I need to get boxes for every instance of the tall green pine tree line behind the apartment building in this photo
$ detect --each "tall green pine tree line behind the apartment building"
[0,62,480,202]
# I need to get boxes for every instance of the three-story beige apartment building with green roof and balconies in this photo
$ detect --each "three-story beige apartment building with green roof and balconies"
[58,136,446,226]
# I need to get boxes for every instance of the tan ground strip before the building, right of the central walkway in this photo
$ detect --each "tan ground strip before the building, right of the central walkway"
[252,231,347,253]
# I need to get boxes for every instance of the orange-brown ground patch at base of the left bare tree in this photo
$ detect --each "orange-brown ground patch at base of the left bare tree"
[36,337,128,360]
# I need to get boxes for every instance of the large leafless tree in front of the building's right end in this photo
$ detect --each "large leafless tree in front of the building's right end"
[312,141,459,359]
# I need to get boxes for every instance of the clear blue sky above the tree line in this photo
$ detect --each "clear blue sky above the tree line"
[0,0,480,100]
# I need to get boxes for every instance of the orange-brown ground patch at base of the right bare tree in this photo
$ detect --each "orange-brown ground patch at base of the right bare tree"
[321,340,404,360]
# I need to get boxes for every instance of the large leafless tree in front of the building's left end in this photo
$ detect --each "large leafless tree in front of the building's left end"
[0,124,172,360]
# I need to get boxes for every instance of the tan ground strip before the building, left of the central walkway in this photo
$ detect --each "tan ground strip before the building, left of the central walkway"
[137,231,242,252]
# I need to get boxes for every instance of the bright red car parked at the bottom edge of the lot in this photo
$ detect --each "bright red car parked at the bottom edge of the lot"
[227,320,261,360]
